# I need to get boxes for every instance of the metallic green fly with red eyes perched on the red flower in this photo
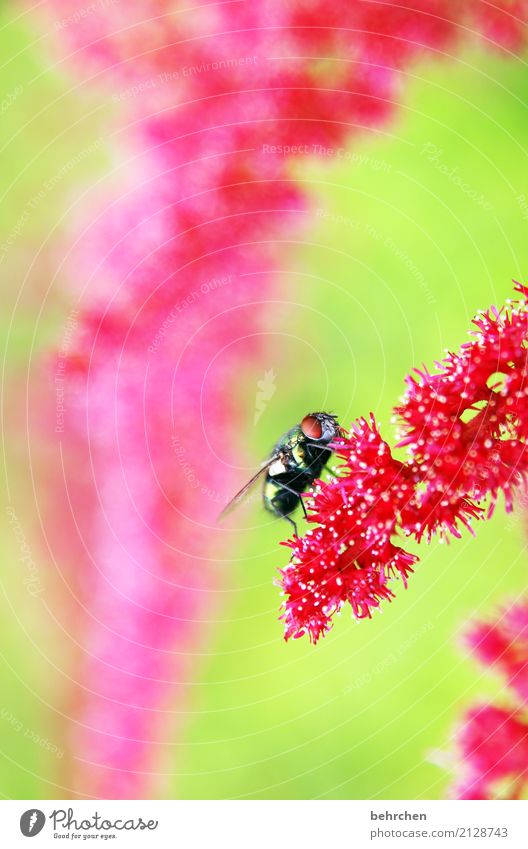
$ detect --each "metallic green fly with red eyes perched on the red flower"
[219,413,342,535]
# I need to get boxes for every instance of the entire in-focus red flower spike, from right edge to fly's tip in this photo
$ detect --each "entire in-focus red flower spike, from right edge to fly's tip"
[280,285,528,643]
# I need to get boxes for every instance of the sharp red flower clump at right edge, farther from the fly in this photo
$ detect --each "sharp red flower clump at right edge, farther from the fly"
[395,285,528,513]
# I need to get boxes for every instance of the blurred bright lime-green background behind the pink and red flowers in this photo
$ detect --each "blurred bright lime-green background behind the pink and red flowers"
[0,6,528,799]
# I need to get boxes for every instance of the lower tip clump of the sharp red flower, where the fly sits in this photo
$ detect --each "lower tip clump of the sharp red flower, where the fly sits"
[282,416,418,643]
